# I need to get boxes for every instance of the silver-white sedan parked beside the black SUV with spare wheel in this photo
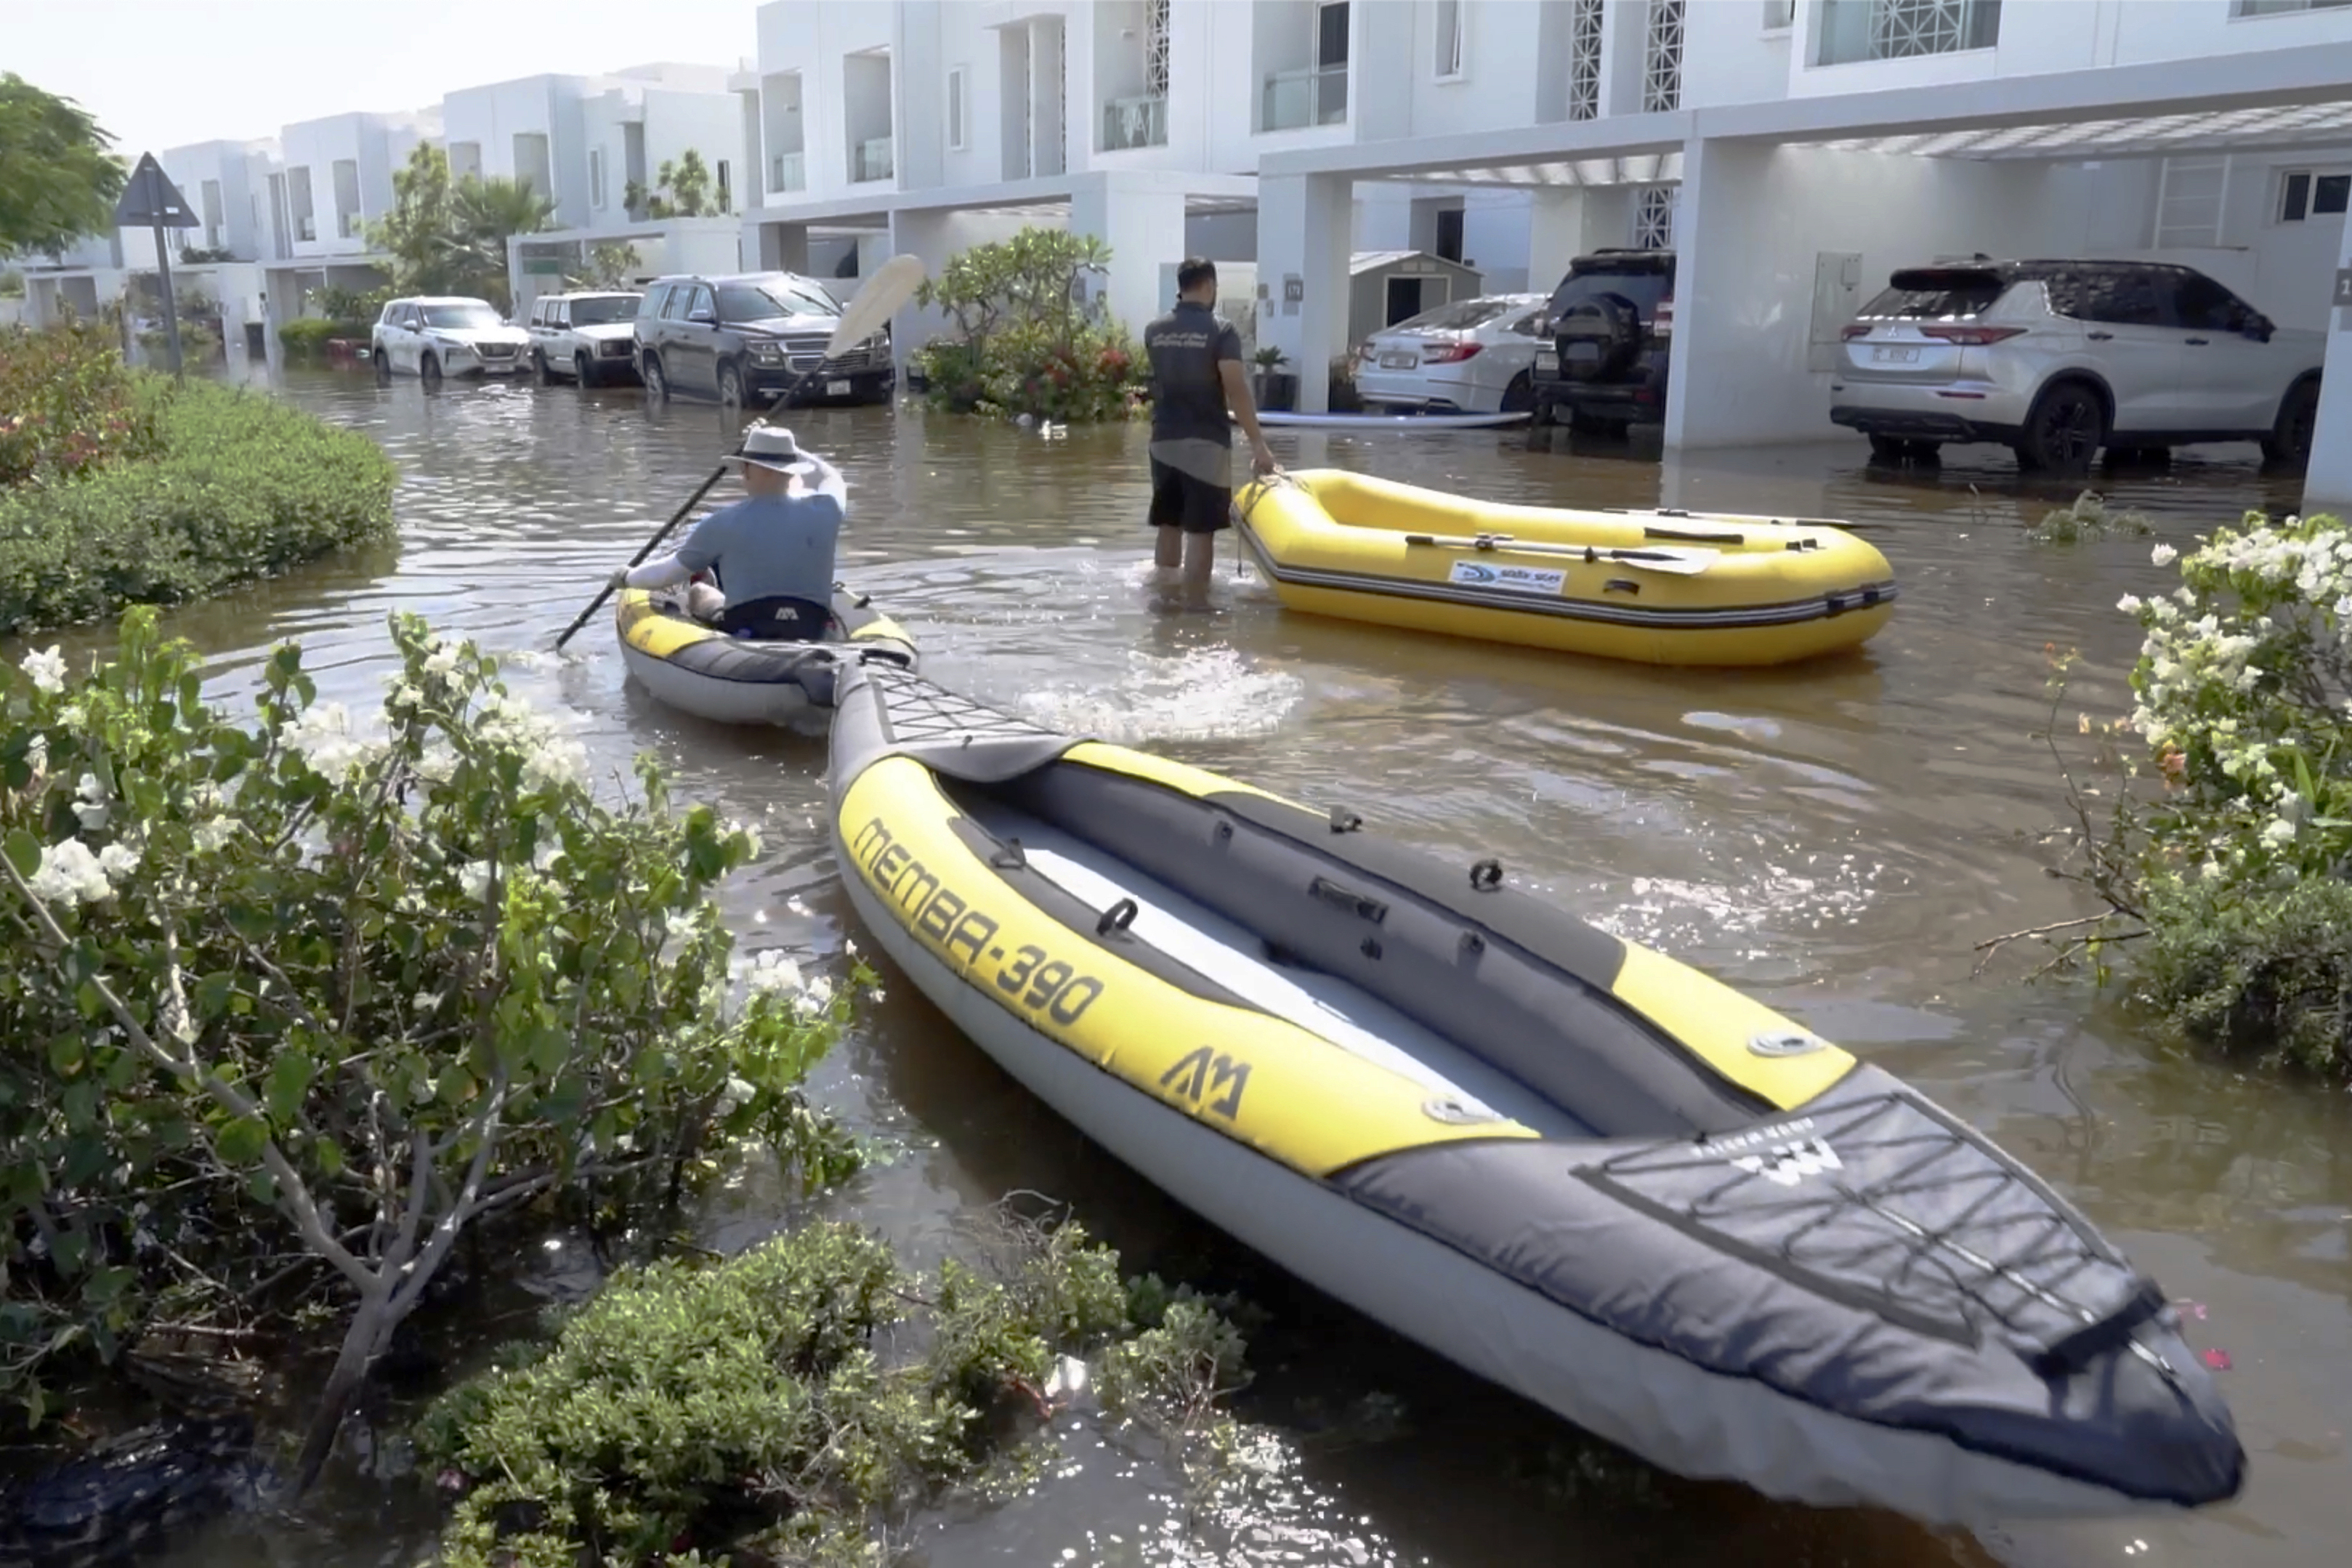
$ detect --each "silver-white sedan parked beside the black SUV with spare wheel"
[1355,294,1543,413]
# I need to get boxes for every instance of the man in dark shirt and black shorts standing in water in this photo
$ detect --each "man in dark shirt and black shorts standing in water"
[1143,256,1282,597]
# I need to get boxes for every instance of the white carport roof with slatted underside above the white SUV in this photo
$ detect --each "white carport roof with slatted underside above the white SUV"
[1258,42,2352,186]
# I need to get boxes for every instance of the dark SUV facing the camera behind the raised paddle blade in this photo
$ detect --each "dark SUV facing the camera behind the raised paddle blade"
[635,272,899,402]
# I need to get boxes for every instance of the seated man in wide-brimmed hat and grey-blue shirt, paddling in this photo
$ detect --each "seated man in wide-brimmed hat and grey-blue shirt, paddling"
[612,426,849,642]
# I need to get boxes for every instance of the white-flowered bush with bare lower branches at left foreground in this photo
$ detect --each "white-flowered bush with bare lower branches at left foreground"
[0,609,846,1486]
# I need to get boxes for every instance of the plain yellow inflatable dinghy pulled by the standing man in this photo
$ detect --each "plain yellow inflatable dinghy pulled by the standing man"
[1234,468,1896,666]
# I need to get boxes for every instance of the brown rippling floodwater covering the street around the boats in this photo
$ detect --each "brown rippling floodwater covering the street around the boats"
[12,371,2352,1568]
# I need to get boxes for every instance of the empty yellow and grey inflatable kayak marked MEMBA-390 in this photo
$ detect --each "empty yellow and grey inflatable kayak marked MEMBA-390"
[831,666,2246,1524]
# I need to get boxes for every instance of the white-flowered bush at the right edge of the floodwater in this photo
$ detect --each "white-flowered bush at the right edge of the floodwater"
[2032,512,2352,1075]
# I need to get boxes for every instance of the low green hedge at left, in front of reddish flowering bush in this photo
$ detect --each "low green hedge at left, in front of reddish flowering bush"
[0,373,397,635]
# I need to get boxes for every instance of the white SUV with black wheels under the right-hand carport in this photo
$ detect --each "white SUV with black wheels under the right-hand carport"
[1830,259,2326,470]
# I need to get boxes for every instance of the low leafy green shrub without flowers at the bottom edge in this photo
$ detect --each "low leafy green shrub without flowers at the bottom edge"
[419,1225,1195,1568]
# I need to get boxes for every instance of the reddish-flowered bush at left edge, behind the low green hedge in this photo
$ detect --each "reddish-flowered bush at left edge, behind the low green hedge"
[0,322,160,484]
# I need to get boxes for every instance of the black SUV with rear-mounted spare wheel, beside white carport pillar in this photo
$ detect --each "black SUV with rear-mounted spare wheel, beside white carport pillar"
[1536,249,1675,430]
